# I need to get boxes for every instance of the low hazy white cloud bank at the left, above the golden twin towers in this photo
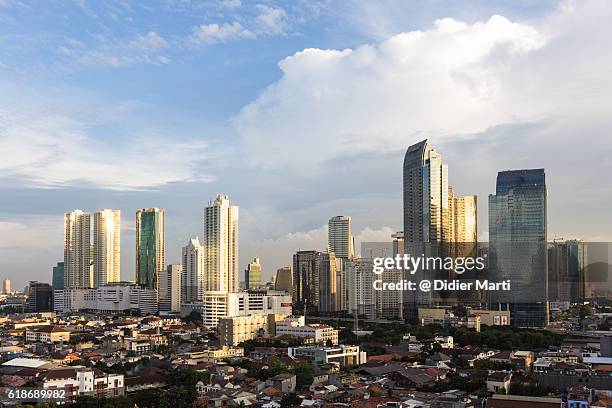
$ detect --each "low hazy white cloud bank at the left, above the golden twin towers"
[0,93,211,190]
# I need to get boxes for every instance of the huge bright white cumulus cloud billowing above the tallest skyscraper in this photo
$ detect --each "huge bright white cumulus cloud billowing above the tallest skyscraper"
[235,16,546,166]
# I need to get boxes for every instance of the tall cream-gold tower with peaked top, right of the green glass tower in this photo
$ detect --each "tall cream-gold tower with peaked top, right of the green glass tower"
[203,194,238,292]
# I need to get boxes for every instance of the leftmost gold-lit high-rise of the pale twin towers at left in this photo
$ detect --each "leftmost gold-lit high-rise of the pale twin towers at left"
[64,210,93,288]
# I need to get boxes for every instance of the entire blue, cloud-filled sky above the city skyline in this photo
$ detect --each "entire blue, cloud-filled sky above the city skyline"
[0,0,612,288]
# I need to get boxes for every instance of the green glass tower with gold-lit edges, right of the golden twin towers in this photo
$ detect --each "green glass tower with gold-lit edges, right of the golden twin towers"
[136,208,166,290]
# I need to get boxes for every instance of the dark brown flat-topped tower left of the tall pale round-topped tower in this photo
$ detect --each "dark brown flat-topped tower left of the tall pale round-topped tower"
[293,251,322,308]
